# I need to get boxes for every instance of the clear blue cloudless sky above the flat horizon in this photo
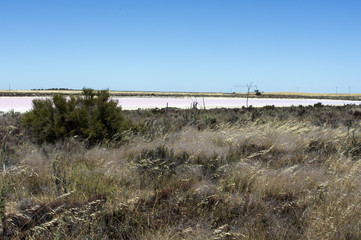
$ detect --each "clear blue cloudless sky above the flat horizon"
[0,0,361,93]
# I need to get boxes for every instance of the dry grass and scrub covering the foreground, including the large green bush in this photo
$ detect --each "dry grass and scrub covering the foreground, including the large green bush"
[0,91,361,240]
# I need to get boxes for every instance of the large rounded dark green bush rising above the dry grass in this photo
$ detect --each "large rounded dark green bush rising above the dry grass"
[23,88,131,145]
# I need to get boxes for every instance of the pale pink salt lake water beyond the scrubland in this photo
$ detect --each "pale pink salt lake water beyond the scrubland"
[0,97,361,112]
